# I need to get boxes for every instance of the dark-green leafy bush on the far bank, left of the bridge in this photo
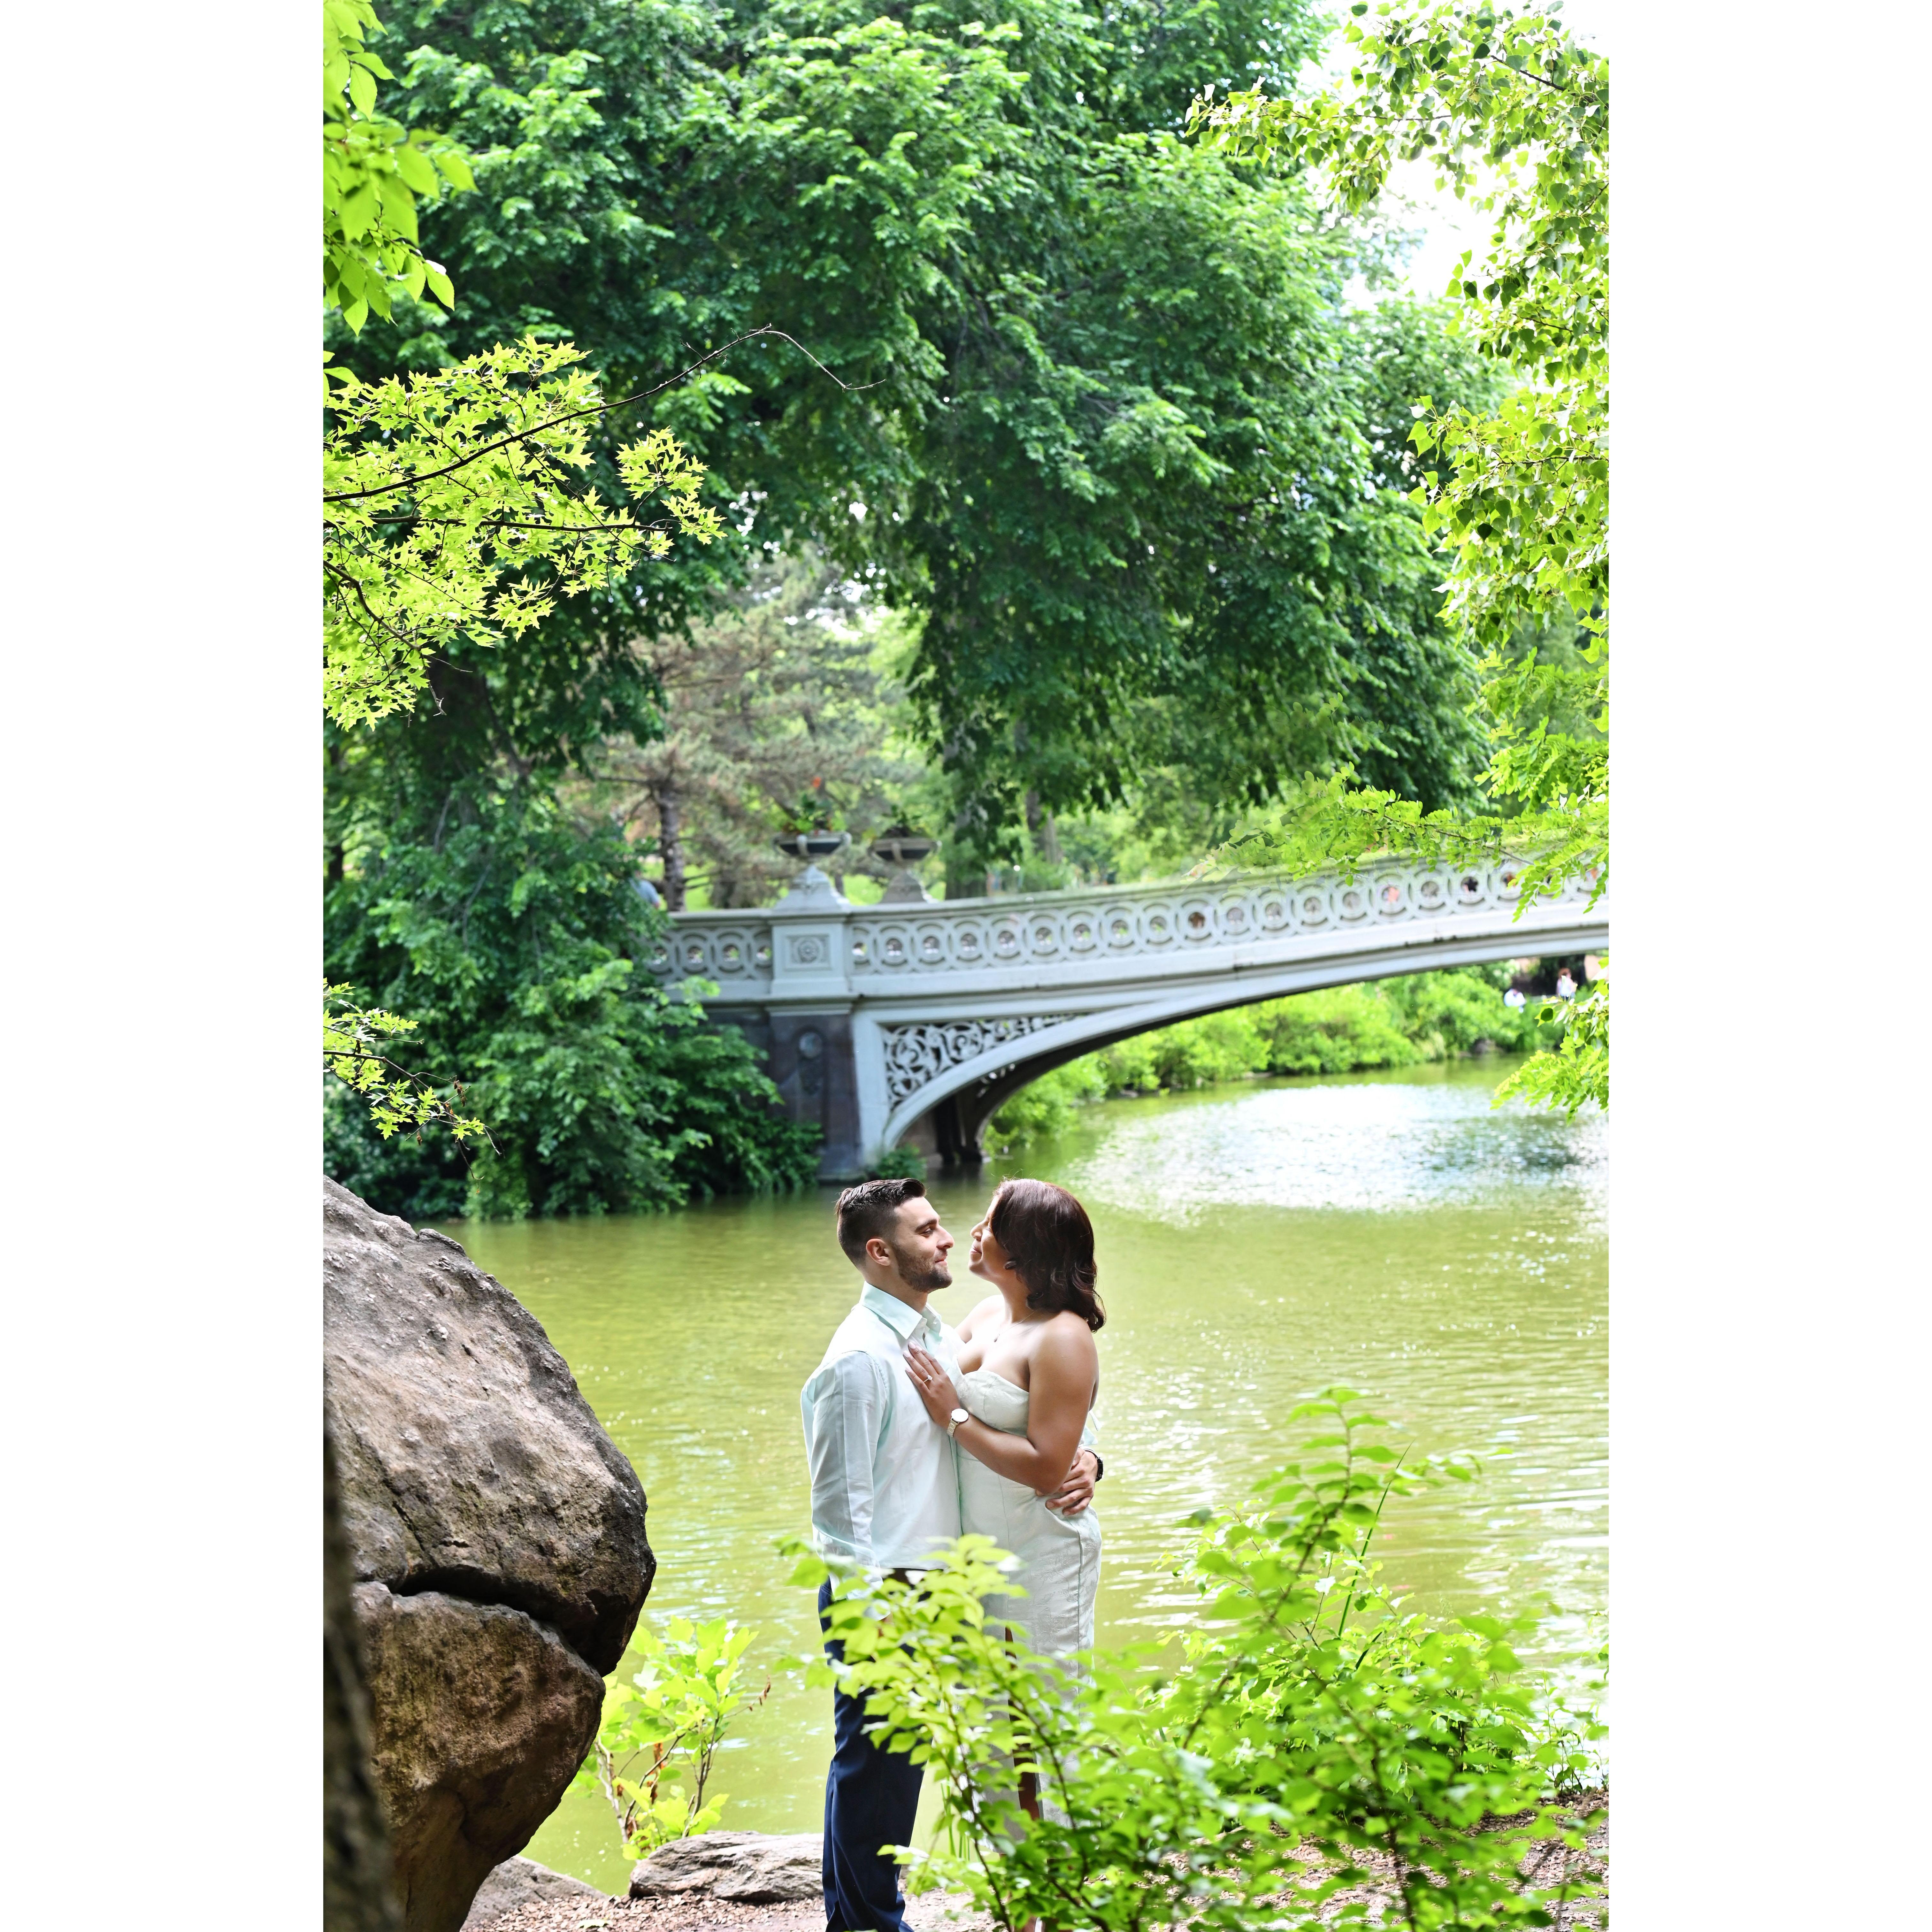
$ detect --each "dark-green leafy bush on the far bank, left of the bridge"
[323,777,817,1221]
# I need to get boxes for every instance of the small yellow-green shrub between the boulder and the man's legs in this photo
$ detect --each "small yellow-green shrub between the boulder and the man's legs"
[574,1617,771,1859]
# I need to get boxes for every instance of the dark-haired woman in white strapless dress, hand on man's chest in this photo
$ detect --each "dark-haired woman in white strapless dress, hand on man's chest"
[906,1180,1107,1658]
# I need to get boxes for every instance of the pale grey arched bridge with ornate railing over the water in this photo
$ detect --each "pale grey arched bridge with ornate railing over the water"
[647,862,1609,1180]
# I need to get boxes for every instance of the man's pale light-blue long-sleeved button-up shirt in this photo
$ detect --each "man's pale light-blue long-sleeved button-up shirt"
[798,1281,960,1569]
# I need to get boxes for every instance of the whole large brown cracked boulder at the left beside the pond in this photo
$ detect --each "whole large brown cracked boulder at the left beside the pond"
[323,1180,655,1932]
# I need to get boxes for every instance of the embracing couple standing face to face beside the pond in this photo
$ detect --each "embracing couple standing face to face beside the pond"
[800,1180,1105,1932]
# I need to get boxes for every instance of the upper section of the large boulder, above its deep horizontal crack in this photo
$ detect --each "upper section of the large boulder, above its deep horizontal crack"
[323,1180,655,1671]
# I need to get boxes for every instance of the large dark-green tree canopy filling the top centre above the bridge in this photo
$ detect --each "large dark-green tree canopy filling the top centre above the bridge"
[344,0,1488,862]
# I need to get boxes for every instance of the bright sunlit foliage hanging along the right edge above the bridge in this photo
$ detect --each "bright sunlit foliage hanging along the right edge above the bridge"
[1194,0,1609,1111]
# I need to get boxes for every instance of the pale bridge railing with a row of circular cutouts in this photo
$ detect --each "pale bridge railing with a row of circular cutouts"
[645,862,1590,999]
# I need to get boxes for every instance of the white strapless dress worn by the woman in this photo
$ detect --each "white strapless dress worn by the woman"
[960,1368,1099,1658]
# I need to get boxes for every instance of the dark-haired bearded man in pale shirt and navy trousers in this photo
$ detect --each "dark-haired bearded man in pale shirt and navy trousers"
[800,1180,1101,1932]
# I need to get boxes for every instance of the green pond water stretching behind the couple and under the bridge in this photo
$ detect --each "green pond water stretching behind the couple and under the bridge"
[450,1061,1609,1890]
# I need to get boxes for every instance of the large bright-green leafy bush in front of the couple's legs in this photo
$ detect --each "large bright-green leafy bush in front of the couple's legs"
[792,1389,1602,1932]
